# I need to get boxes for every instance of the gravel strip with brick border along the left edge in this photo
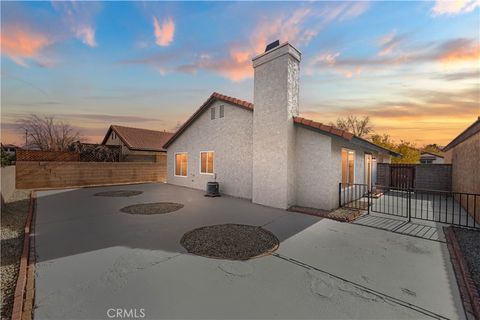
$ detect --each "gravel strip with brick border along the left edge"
[0,190,30,319]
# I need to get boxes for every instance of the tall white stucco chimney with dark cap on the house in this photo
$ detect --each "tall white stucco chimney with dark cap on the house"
[252,40,301,209]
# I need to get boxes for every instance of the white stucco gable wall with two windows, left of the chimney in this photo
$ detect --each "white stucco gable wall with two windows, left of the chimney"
[167,101,253,199]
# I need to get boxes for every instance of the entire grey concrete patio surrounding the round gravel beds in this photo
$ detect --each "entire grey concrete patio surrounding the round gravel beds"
[34,184,465,319]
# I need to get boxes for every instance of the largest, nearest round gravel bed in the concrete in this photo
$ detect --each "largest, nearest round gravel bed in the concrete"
[180,224,280,260]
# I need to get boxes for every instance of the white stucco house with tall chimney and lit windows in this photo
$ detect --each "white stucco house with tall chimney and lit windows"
[164,43,398,210]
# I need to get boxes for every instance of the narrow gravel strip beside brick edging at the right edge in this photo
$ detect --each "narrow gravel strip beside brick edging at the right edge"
[453,228,480,294]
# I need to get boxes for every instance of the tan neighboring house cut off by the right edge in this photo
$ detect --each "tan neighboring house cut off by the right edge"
[443,117,480,196]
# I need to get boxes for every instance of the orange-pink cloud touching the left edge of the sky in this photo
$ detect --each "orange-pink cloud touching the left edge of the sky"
[0,27,51,66]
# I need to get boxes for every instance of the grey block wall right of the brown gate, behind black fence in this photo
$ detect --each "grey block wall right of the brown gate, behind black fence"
[415,164,452,191]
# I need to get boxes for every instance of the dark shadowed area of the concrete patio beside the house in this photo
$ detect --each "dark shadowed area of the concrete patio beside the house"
[35,183,321,263]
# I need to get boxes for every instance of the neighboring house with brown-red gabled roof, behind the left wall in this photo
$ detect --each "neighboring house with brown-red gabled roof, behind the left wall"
[102,125,173,162]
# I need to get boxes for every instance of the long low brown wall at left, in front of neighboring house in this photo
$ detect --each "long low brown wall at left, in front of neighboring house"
[16,159,167,189]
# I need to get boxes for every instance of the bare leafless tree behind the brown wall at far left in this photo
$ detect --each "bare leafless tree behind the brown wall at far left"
[18,114,82,151]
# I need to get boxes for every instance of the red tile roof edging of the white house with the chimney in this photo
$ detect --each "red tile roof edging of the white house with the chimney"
[163,92,400,156]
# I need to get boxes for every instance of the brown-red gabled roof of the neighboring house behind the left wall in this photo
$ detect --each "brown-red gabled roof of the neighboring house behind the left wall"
[102,125,173,151]
